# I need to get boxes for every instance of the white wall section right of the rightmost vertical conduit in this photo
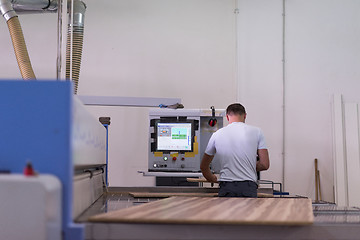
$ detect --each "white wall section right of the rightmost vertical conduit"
[286,0,360,200]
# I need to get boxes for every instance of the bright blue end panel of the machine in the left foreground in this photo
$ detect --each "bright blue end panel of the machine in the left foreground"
[0,80,106,240]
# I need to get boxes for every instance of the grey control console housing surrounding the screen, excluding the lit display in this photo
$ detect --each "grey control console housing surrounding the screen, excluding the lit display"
[148,109,225,173]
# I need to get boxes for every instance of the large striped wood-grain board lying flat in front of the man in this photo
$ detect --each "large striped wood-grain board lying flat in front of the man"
[89,197,314,225]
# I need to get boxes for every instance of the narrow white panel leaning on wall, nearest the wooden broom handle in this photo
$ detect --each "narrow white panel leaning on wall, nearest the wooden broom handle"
[332,94,348,206]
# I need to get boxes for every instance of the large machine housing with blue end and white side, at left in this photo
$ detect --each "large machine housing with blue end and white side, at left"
[0,80,106,240]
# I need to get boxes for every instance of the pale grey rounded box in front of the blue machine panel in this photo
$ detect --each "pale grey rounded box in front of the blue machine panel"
[0,174,62,240]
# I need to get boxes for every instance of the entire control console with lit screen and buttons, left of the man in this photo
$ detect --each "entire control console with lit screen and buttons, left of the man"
[148,109,224,172]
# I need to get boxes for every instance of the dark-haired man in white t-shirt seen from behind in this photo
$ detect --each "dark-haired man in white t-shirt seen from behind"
[200,103,270,197]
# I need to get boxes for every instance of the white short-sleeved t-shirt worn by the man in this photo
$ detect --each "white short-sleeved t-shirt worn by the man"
[205,122,266,182]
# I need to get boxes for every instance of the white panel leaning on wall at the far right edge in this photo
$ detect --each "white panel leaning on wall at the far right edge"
[344,103,360,207]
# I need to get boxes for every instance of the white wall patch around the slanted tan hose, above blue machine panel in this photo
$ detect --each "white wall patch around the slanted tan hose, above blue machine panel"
[0,13,57,79]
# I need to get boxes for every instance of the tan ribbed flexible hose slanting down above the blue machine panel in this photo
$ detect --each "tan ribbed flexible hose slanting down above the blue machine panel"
[7,16,36,80]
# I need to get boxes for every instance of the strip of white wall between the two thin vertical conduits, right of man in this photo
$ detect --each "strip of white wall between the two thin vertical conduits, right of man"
[237,0,283,188]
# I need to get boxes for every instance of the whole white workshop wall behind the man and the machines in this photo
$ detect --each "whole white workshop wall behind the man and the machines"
[0,0,360,201]
